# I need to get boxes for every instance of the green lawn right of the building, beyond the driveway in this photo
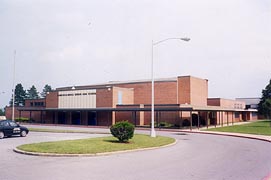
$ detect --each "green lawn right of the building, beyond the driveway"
[207,120,271,136]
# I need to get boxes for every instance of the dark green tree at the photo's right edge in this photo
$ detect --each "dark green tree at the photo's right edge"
[258,79,271,118]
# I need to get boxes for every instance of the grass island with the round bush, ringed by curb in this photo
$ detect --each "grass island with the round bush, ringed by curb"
[17,134,175,154]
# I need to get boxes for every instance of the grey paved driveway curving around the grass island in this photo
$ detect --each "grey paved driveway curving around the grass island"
[0,126,271,180]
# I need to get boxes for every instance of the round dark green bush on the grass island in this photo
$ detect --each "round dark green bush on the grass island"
[110,121,135,142]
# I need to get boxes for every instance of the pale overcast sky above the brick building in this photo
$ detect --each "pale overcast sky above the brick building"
[0,0,271,107]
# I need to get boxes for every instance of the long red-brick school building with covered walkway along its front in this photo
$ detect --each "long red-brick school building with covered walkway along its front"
[6,76,257,128]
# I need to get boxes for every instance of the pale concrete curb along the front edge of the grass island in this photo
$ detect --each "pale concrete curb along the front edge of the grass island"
[13,139,177,157]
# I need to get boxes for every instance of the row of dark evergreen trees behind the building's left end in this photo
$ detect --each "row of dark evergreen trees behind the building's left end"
[9,83,53,106]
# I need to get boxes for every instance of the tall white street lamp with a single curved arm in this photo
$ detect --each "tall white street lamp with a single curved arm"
[151,37,190,137]
